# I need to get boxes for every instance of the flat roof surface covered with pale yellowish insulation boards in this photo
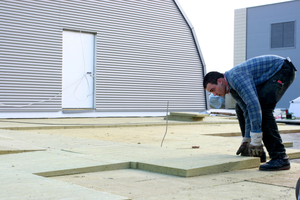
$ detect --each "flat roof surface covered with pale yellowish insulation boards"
[0,116,300,200]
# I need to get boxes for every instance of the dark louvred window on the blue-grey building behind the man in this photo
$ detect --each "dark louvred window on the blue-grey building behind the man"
[271,21,295,48]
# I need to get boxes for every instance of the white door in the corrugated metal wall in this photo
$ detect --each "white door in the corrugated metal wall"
[62,31,95,109]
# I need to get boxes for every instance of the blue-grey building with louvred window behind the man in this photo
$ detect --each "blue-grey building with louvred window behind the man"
[234,0,300,108]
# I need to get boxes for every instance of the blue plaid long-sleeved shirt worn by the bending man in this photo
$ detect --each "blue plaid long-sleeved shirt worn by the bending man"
[224,55,285,138]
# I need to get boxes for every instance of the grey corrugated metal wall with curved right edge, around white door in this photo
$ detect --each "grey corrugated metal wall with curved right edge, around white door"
[0,0,206,112]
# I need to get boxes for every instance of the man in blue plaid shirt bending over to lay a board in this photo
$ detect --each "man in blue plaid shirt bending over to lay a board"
[203,55,297,171]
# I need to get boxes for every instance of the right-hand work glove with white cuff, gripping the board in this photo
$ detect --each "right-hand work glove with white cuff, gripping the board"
[249,132,264,157]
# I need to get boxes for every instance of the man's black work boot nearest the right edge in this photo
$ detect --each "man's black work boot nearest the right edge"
[259,156,291,171]
